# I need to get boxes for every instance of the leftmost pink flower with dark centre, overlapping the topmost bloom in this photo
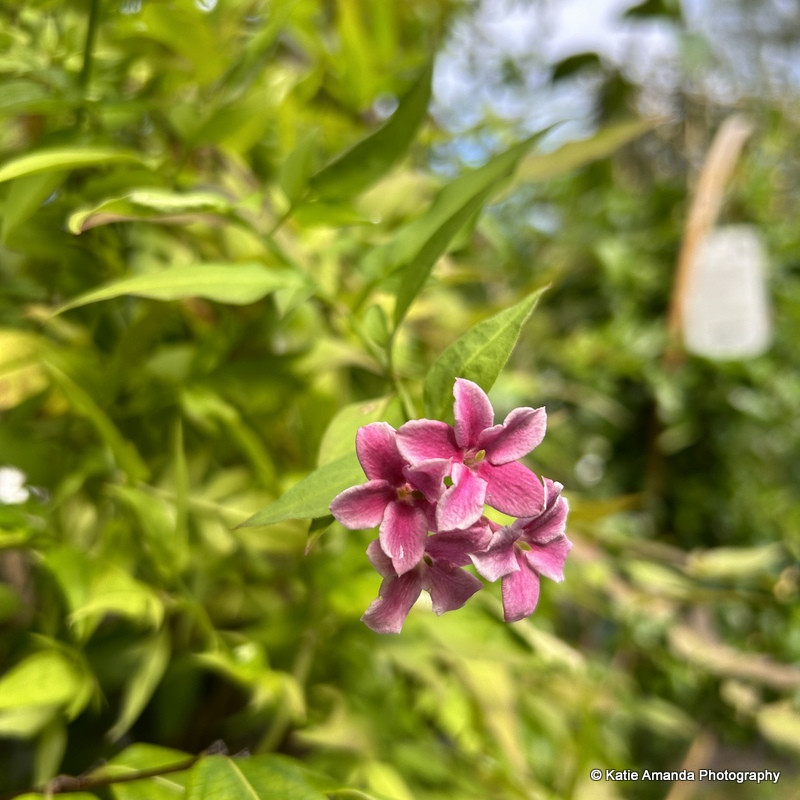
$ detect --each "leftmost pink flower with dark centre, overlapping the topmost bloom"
[330,422,448,575]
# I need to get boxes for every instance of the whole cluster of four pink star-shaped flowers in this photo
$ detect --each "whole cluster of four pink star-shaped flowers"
[331,378,572,633]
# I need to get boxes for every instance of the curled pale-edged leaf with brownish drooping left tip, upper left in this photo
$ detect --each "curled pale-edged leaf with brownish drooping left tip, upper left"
[67,188,231,234]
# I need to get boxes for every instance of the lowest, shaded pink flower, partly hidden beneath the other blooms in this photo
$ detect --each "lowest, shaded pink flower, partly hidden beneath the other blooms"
[361,527,489,633]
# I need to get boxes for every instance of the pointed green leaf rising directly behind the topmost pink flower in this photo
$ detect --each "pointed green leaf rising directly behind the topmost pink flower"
[423,287,546,419]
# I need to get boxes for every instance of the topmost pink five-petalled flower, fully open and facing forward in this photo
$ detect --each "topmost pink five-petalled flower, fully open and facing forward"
[397,378,547,530]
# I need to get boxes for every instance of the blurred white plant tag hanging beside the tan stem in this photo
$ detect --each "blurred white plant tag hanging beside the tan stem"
[683,225,772,359]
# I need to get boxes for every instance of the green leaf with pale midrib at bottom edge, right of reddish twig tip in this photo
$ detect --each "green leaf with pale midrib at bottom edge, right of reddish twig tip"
[186,755,326,800]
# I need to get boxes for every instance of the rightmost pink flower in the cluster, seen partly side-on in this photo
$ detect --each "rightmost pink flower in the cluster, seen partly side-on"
[470,478,572,622]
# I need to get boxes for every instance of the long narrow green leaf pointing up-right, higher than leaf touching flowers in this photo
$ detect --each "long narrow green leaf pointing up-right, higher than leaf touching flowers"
[378,137,537,326]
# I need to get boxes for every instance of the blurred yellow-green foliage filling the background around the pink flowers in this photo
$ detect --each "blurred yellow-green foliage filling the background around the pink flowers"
[0,0,800,800]
